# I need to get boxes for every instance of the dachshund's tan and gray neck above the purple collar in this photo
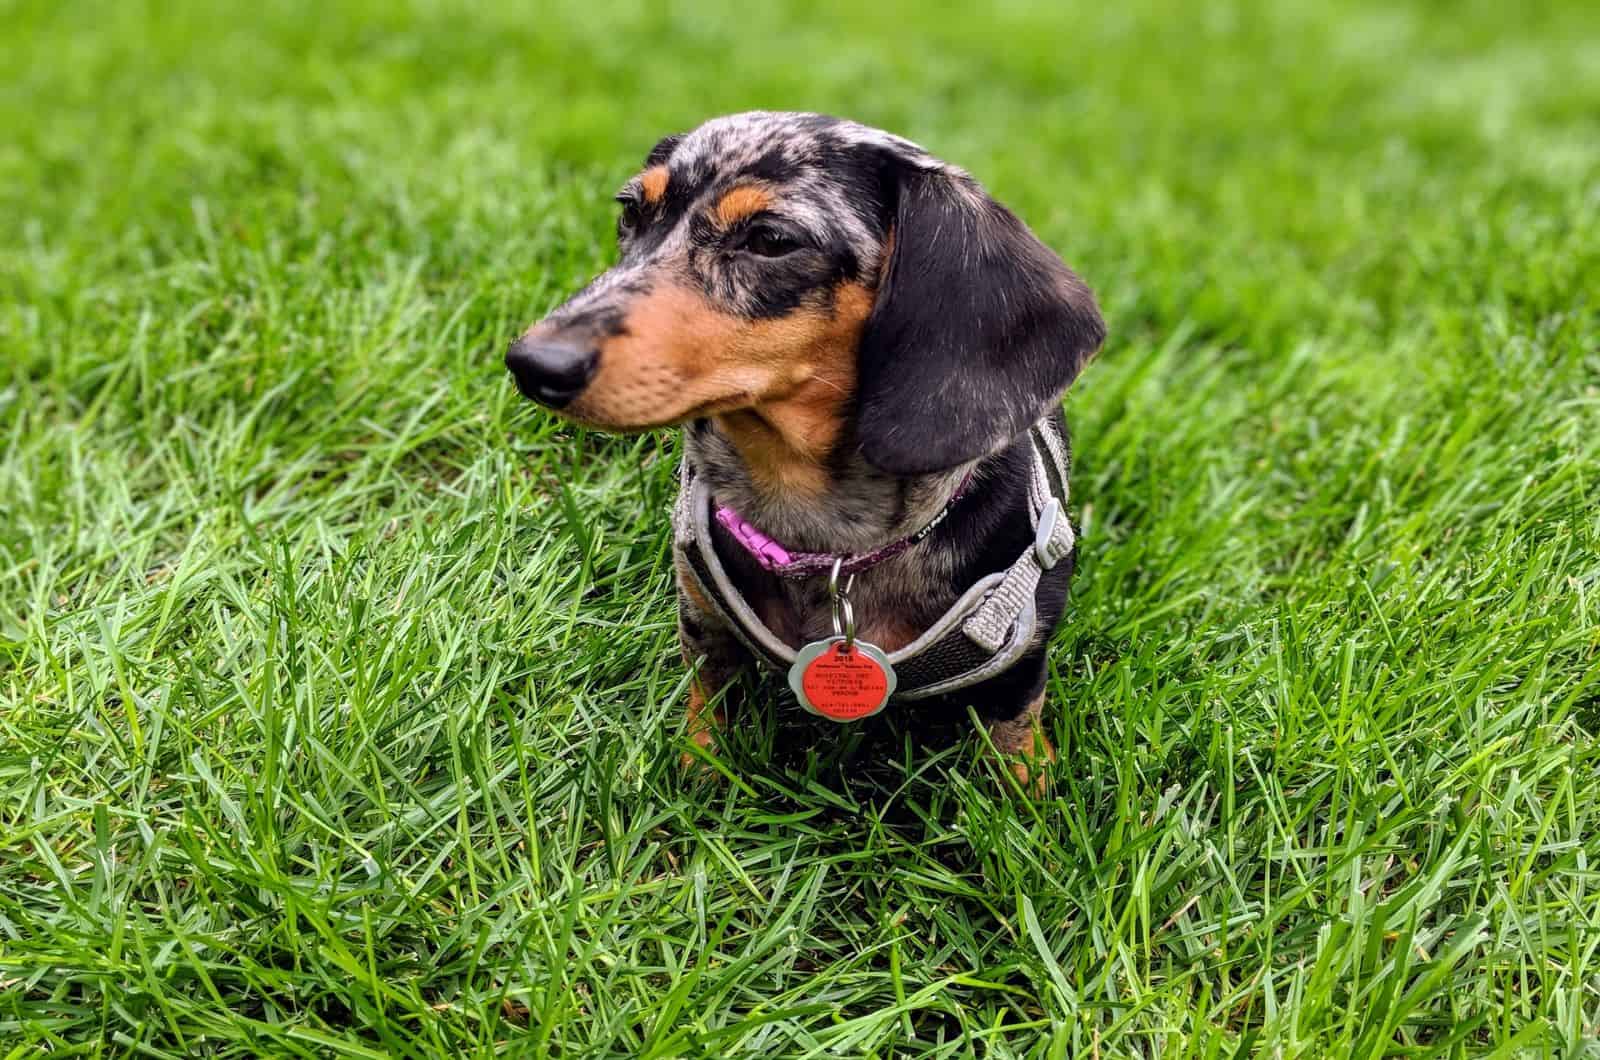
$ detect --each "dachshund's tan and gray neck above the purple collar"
[683,412,970,552]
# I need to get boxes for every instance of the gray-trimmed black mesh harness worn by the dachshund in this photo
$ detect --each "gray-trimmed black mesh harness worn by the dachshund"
[672,416,1075,700]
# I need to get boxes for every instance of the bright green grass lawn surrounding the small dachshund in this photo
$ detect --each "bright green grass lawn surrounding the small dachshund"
[0,0,1600,1058]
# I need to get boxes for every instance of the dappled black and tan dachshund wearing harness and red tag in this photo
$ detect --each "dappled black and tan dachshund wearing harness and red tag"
[506,112,1106,786]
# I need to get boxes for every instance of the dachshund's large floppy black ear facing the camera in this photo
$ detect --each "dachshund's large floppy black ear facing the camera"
[858,162,1106,474]
